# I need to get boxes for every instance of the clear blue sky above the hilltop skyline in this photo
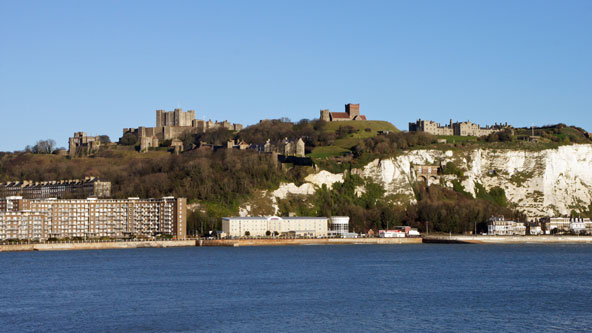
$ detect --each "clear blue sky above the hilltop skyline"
[0,0,592,151]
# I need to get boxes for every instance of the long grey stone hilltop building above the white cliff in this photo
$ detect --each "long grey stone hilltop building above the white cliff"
[409,119,509,136]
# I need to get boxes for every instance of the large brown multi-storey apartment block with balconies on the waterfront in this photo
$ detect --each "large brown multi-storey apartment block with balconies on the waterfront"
[0,196,187,241]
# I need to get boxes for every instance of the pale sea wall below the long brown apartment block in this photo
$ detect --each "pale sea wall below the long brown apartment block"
[0,240,196,252]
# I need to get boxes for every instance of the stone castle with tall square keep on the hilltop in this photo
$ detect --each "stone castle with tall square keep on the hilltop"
[123,109,243,151]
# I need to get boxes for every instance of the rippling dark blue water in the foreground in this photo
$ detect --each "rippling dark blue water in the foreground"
[0,244,592,332]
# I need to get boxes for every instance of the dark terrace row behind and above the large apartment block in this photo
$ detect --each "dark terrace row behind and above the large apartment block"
[0,177,111,199]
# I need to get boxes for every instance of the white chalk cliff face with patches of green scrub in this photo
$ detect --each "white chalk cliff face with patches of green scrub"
[243,145,592,217]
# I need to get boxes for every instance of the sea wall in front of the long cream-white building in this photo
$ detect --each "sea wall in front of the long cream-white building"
[197,238,422,246]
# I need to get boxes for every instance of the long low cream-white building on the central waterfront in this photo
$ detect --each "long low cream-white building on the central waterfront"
[222,216,328,237]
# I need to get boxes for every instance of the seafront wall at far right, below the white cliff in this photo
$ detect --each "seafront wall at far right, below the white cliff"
[423,235,592,244]
